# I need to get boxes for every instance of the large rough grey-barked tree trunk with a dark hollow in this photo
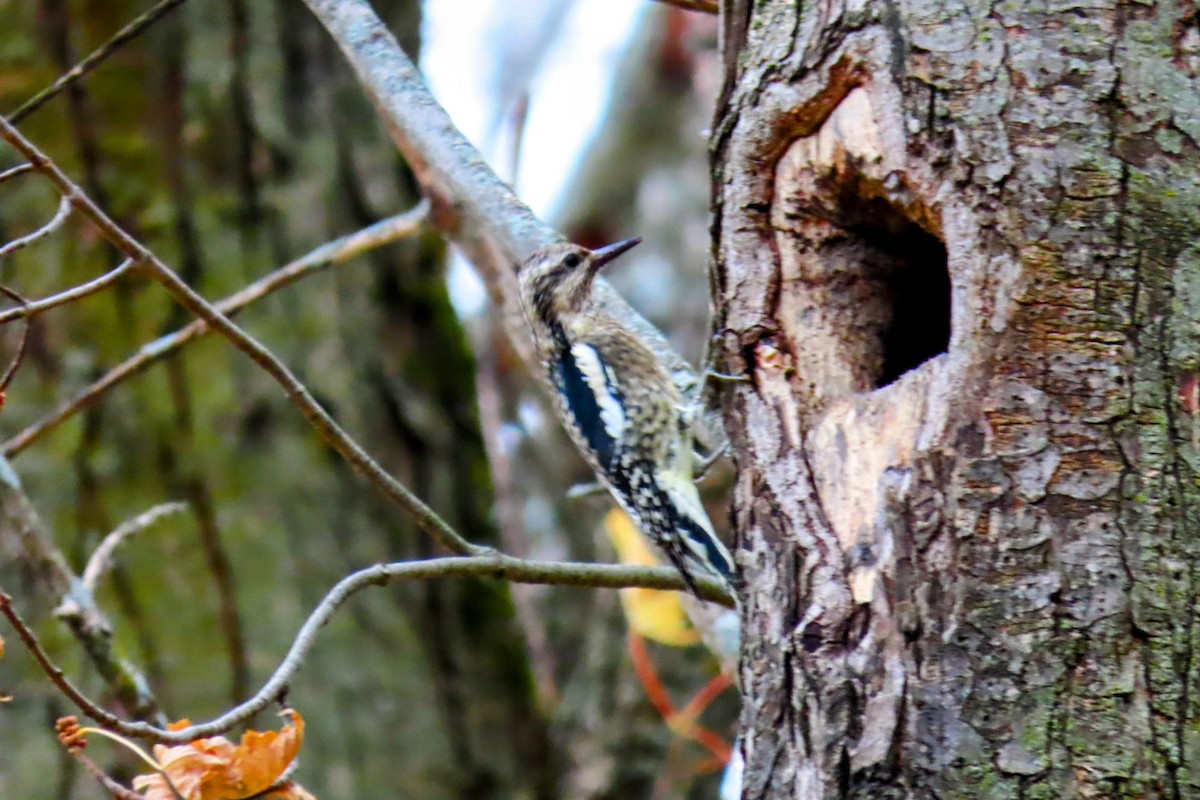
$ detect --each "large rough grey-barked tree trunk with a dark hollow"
[712,0,1200,800]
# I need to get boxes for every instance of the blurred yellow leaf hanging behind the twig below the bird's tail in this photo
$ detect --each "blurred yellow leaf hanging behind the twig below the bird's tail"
[604,509,700,648]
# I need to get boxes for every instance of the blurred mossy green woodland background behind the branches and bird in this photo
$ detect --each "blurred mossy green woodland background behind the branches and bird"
[0,0,736,800]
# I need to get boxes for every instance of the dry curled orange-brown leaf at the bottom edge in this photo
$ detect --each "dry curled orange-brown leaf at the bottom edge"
[133,710,314,800]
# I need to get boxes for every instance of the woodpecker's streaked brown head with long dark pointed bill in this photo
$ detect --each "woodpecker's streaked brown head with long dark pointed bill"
[517,239,642,325]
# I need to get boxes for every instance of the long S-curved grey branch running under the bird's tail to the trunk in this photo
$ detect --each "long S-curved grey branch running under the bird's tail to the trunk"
[0,554,733,742]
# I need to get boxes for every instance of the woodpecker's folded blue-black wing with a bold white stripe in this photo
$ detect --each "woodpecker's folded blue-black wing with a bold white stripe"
[558,342,629,473]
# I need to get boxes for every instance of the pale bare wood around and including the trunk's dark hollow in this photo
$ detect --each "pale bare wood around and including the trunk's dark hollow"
[770,88,950,603]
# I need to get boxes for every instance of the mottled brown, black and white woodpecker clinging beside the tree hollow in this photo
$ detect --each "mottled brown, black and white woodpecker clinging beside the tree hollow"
[517,239,734,594]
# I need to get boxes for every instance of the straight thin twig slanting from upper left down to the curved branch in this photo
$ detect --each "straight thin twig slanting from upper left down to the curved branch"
[0,116,477,555]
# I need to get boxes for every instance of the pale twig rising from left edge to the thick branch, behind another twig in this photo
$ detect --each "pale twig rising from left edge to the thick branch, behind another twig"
[0,200,430,457]
